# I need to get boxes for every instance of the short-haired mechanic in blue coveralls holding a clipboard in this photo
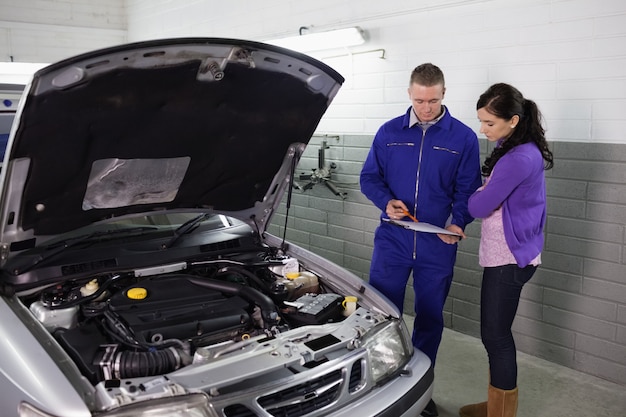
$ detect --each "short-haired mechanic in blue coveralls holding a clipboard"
[360,63,481,415]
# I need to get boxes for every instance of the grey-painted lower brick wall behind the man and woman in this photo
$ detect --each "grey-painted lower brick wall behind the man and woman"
[270,135,626,385]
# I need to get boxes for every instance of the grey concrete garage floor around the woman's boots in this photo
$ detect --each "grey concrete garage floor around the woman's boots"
[405,316,626,417]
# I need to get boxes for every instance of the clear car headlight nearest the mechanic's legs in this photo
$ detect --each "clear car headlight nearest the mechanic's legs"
[362,321,413,383]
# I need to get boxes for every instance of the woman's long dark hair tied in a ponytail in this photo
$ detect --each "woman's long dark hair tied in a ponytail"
[476,83,554,177]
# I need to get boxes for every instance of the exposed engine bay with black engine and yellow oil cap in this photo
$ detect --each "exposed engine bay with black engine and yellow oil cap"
[26,257,345,385]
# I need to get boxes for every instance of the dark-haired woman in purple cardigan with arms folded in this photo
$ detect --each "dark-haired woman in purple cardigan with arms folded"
[459,83,553,417]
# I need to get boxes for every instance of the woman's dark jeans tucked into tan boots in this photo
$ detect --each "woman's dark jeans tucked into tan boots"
[480,265,537,390]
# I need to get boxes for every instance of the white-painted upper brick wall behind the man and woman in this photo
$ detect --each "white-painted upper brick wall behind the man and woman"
[120,0,626,143]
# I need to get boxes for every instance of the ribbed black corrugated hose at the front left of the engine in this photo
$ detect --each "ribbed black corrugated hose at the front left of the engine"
[113,347,182,379]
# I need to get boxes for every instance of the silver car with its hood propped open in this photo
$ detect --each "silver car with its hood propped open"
[0,38,433,417]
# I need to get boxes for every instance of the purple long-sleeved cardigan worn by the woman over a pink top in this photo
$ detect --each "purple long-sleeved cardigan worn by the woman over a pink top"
[469,143,546,268]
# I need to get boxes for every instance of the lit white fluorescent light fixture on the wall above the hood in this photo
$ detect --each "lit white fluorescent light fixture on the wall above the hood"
[266,27,365,52]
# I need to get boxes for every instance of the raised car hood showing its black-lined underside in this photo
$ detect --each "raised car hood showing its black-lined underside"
[0,38,344,250]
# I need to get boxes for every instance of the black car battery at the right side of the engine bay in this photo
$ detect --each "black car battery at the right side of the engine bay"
[289,294,343,325]
